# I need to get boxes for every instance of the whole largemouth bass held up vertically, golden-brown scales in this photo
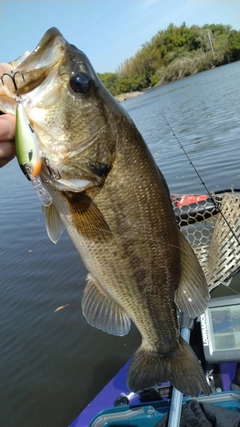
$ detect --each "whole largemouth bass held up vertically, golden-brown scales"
[0,28,209,396]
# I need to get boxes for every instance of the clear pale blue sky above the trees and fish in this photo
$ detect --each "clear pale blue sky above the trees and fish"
[0,0,240,73]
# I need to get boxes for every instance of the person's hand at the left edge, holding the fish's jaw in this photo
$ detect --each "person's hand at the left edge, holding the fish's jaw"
[0,64,16,167]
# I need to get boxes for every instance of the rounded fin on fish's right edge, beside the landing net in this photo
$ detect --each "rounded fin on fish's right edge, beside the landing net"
[175,235,209,319]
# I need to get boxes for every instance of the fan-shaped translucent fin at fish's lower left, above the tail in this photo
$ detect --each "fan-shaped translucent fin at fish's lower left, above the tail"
[82,274,131,336]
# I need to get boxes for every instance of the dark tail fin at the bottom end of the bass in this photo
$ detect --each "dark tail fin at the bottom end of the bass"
[127,337,209,397]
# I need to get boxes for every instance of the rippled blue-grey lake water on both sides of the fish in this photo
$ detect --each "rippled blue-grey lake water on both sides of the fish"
[0,62,240,427]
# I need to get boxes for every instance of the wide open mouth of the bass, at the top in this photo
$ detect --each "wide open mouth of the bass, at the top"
[12,27,67,95]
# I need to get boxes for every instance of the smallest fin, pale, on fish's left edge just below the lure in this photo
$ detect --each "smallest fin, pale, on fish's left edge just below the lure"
[43,203,64,243]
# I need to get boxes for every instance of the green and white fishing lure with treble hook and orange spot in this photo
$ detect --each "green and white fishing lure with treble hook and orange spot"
[1,71,52,206]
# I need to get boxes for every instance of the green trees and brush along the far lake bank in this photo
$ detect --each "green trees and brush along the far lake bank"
[98,23,240,96]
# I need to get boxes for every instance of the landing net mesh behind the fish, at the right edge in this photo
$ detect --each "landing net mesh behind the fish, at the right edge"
[174,191,240,291]
